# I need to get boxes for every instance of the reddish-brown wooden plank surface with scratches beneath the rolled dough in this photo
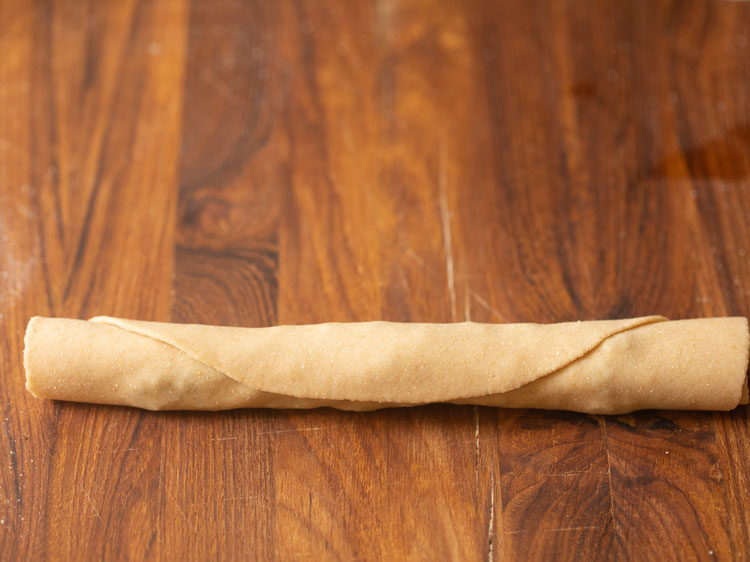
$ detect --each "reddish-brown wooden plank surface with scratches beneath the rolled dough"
[0,0,750,561]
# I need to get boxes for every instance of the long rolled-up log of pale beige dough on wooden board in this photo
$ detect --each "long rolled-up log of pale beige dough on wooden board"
[24,316,750,414]
